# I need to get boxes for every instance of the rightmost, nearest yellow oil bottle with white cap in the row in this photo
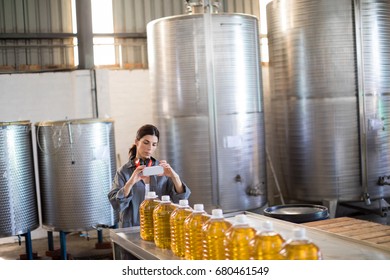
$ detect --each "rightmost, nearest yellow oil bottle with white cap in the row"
[280,228,322,260]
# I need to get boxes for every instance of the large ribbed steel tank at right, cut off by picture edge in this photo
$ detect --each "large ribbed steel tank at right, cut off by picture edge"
[267,0,390,204]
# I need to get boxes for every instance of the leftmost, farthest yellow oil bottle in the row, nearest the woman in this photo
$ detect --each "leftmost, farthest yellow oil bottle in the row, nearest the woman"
[139,192,159,241]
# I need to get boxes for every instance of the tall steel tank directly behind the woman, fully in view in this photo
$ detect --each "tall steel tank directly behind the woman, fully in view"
[147,6,267,212]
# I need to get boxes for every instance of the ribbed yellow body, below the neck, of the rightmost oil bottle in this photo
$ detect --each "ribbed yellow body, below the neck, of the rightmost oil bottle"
[281,240,322,260]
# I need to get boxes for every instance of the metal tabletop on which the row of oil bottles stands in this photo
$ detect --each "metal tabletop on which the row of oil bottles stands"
[110,212,390,260]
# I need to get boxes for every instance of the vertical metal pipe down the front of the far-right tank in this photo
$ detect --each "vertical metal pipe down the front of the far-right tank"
[354,0,371,205]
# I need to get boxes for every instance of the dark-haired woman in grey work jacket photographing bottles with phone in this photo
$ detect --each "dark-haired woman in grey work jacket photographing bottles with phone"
[108,124,191,227]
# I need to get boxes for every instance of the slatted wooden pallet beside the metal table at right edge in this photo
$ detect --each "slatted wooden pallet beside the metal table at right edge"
[304,217,390,250]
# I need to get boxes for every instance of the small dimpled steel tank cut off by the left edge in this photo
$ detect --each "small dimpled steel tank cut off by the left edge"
[0,121,39,237]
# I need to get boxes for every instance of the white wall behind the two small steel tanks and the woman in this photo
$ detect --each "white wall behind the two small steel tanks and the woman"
[0,70,153,246]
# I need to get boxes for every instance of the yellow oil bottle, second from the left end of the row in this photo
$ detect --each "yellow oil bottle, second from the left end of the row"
[153,195,175,249]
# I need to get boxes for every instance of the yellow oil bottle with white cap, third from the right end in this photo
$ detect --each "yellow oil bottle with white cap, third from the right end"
[224,214,256,260]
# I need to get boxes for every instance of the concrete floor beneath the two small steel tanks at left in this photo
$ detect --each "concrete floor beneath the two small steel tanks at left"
[0,230,113,260]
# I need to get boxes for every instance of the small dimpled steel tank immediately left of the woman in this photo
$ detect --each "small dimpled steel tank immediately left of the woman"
[35,119,117,232]
